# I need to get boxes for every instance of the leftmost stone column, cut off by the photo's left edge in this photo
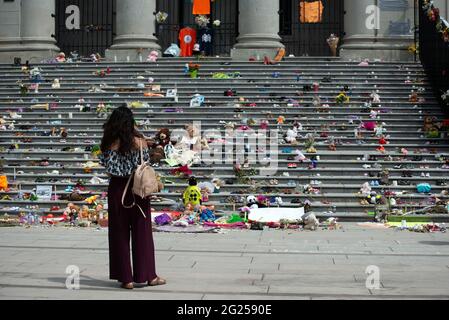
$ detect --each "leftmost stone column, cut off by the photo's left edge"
[0,0,59,63]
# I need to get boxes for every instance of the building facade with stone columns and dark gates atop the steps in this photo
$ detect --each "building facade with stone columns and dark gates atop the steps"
[0,0,434,62]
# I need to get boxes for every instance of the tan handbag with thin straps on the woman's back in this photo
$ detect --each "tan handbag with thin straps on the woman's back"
[122,142,164,218]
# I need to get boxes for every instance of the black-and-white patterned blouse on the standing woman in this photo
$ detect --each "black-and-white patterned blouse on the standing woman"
[98,149,150,177]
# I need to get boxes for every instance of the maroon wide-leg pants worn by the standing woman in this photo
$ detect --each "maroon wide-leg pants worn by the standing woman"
[108,177,157,283]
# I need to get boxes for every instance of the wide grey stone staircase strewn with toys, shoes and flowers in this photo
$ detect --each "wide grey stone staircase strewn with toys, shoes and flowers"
[0,58,449,220]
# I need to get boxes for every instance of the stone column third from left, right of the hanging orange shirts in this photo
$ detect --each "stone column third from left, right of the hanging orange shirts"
[231,0,284,60]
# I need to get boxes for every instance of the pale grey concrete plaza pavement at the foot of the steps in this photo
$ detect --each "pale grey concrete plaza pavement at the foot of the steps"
[0,223,449,300]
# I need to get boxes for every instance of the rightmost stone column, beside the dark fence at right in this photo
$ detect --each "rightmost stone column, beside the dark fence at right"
[340,0,414,61]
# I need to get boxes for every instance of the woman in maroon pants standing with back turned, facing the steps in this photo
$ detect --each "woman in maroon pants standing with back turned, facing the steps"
[100,105,166,289]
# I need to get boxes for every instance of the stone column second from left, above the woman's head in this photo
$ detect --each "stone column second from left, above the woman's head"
[106,0,161,61]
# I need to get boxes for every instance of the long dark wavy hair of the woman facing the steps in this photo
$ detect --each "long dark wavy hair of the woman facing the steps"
[100,104,142,154]
